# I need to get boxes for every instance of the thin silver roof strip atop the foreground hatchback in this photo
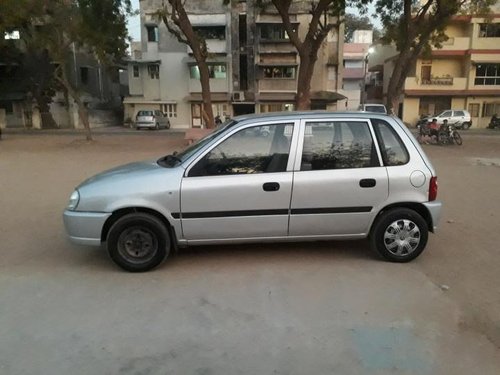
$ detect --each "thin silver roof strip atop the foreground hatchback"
[233,111,392,122]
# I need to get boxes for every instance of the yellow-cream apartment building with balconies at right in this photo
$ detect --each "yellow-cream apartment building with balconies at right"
[384,5,500,128]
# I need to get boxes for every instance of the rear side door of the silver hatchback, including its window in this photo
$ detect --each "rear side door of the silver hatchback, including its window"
[289,119,389,236]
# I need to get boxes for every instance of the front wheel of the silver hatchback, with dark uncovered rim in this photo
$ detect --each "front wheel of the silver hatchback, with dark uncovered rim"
[107,212,171,272]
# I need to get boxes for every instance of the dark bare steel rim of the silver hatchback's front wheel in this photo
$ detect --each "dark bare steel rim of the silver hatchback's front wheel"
[118,227,158,264]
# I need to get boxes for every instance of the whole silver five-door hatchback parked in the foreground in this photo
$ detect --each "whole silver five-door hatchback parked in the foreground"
[64,112,441,272]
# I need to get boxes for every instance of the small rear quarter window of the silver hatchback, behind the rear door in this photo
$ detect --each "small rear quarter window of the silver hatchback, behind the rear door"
[371,119,410,167]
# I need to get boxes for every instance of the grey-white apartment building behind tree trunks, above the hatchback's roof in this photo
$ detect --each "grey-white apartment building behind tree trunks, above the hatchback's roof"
[124,0,344,128]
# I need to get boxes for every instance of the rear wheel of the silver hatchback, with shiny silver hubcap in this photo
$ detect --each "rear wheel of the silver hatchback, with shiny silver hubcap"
[370,208,429,263]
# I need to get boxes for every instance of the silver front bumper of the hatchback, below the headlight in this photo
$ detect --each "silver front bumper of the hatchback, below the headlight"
[63,210,111,246]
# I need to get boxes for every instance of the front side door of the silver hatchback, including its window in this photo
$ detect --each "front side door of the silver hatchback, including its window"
[181,123,296,241]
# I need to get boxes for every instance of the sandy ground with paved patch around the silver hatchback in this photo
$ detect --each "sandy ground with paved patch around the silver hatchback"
[0,131,500,375]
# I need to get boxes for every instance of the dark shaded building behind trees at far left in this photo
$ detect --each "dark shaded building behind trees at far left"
[0,31,124,128]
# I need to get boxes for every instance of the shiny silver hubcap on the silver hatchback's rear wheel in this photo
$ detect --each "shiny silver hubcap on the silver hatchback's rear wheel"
[384,219,421,257]
